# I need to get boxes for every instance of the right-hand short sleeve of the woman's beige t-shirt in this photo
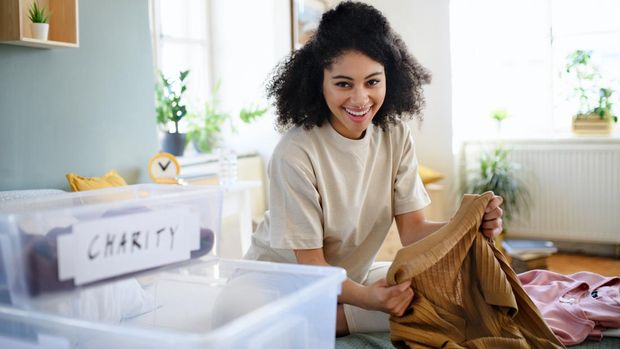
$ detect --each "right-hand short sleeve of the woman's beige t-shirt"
[394,125,431,216]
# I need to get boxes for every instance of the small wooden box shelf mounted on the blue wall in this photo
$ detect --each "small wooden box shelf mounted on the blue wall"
[0,0,79,48]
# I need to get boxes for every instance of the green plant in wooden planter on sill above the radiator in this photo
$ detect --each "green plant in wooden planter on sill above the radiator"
[565,50,618,133]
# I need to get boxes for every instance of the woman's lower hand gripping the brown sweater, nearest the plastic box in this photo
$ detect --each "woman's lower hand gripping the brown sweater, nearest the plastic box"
[364,278,413,316]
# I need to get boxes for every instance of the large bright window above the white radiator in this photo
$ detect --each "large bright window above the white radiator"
[450,0,620,144]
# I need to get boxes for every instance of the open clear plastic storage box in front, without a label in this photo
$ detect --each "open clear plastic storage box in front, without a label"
[0,257,346,349]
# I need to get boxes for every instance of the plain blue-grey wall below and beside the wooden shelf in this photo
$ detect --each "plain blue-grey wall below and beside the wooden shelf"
[0,0,159,190]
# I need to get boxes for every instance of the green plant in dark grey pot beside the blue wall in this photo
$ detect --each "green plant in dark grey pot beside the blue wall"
[155,70,189,156]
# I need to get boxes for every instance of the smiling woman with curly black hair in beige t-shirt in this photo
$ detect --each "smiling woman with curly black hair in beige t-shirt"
[246,2,502,335]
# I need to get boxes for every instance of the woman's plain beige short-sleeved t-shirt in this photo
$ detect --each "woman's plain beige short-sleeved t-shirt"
[245,122,430,282]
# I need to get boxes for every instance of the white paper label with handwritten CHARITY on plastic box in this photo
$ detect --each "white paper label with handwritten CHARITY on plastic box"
[58,208,200,285]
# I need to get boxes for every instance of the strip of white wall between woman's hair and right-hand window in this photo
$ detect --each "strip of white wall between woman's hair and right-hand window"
[365,0,457,218]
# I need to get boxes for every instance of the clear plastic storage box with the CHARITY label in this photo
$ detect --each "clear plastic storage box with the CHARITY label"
[0,185,222,305]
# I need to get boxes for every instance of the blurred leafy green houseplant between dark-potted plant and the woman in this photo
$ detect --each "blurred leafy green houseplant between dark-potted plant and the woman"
[187,81,269,153]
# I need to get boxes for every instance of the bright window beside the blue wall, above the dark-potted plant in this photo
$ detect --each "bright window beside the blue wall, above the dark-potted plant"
[151,0,212,129]
